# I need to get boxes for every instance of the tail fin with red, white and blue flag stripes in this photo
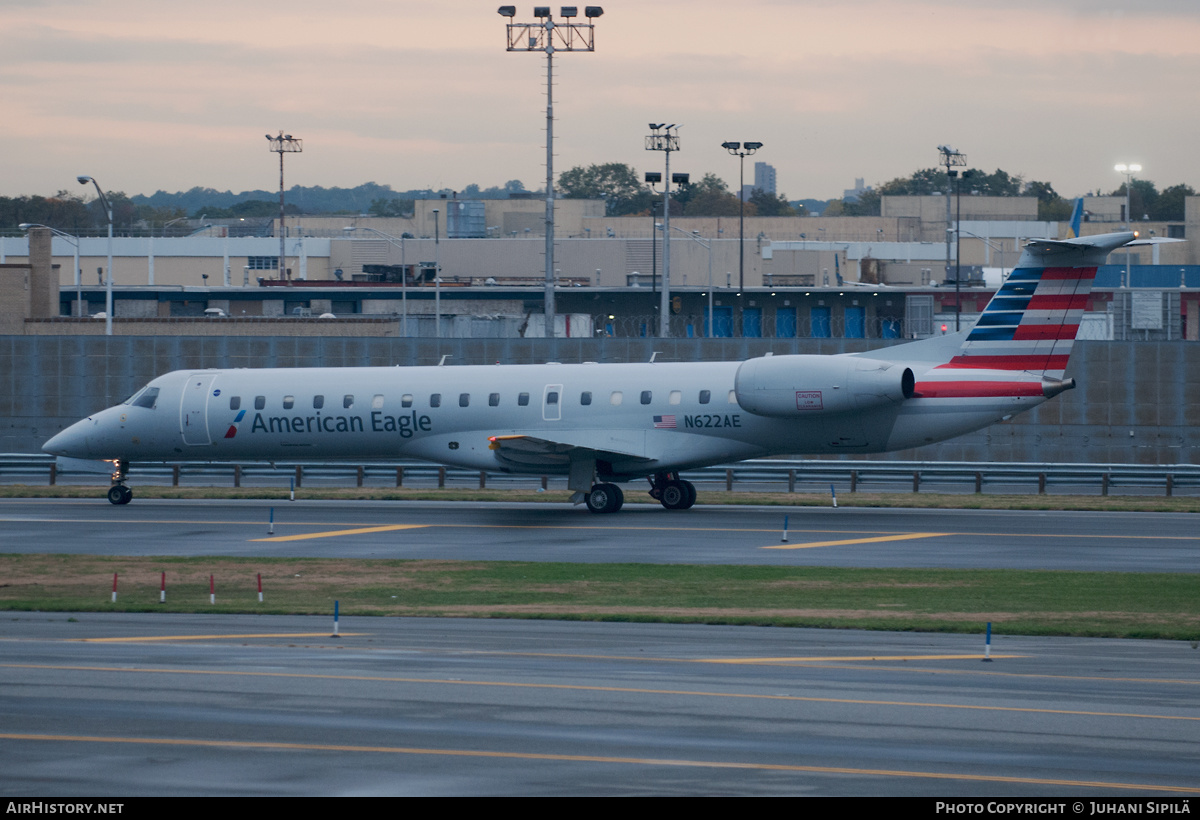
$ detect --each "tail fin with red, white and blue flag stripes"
[943,233,1132,379]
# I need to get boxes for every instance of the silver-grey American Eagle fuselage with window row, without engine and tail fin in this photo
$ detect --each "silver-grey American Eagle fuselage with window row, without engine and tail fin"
[47,357,1042,479]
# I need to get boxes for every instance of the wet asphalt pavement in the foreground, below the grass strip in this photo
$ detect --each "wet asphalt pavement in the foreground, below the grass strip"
[0,613,1200,797]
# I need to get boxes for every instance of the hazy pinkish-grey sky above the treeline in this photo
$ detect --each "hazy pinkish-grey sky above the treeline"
[0,0,1200,198]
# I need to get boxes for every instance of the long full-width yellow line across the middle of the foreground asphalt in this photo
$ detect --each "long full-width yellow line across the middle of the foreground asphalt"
[0,664,1200,722]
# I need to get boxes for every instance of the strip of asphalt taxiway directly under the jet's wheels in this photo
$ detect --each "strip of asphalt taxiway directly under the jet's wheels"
[0,498,1200,573]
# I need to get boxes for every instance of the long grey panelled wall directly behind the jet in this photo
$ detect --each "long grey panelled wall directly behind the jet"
[0,336,1200,465]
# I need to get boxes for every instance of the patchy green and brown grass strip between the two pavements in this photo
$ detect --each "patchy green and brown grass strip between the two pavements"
[0,555,1200,641]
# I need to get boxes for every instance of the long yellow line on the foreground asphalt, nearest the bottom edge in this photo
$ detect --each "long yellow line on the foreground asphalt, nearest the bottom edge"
[0,732,1200,795]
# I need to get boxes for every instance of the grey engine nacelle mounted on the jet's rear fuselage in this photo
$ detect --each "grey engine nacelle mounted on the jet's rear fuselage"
[733,355,917,417]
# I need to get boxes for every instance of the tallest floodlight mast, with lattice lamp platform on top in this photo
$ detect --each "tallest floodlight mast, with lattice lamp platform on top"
[496,6,604,337]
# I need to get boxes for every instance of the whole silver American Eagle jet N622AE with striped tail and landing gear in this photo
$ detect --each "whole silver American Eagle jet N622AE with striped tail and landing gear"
[44,233,1156,513]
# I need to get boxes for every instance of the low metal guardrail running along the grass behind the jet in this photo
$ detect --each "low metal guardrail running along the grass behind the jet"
[0,454,1200,497]
